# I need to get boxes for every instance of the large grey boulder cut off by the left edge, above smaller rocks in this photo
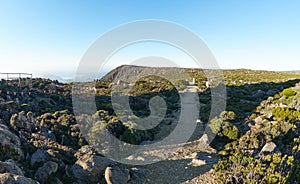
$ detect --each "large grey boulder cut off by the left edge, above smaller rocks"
[0,124,24,159]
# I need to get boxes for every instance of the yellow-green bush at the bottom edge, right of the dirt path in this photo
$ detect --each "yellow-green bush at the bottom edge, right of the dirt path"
[214,153,293,184]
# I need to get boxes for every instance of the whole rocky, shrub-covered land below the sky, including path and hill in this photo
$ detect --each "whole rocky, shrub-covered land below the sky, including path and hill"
[0,66,300,184]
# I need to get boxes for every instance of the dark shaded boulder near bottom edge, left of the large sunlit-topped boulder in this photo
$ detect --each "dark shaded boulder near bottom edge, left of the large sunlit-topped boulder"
[35,161,58,184]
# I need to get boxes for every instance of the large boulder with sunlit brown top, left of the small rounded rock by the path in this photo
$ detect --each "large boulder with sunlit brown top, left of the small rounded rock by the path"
[72,154,114,183]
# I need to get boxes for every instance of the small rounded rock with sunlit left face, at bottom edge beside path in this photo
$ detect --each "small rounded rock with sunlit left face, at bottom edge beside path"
[105,166,130,184]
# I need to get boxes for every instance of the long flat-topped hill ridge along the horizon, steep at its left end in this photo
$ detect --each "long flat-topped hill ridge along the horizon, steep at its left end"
[101,65,300,86]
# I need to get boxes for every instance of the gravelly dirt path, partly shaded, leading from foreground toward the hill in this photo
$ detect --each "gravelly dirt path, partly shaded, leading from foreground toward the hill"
[125,86,219,184]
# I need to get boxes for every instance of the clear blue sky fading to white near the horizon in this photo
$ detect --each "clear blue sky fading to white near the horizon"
[0,0,300,78]
